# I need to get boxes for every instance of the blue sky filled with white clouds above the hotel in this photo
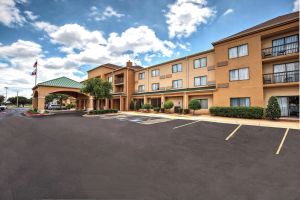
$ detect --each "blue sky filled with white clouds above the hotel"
[0,0,299,97]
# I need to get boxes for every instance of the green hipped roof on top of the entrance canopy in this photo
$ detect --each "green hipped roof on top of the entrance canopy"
[37,76,81,89]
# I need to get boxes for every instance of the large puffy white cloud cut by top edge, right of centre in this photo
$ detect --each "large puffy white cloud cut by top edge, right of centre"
[165,0,216,38]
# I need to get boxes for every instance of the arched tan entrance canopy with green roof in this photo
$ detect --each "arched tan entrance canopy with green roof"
[32,77,90,111]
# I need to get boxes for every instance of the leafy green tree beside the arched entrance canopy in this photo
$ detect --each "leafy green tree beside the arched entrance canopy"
[81,78,112,99]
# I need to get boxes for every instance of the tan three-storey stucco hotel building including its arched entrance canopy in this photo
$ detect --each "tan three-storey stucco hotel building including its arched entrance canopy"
[33,12,299,116]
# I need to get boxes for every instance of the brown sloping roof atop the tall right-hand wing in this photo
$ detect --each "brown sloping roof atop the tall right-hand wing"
[212,12,299,45]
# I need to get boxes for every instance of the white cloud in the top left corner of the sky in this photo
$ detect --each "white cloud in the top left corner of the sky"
[0,0,26,27]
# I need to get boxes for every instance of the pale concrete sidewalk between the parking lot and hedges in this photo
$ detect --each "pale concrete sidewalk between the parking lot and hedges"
[120,111,300,129]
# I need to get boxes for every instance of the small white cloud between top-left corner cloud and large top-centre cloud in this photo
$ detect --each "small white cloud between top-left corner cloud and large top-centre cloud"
[89,6,125,21]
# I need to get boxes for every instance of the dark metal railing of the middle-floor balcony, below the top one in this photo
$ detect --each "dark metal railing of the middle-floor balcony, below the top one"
[263,70,299,84]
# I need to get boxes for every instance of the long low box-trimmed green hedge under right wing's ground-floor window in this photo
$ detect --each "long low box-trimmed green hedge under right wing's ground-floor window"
[209,107,264,119]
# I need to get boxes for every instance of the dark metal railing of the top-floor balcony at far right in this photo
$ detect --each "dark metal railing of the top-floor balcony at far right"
[262,42,299,58]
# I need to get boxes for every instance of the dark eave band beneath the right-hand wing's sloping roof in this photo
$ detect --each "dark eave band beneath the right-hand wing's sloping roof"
[212,17,299,46]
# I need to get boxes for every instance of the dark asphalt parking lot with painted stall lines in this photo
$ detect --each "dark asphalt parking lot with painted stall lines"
[0,110,300,200]
